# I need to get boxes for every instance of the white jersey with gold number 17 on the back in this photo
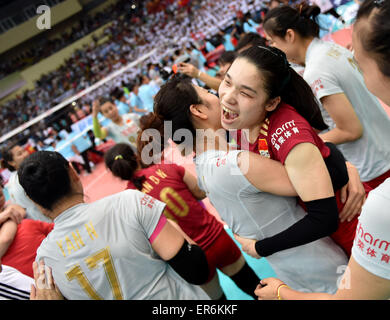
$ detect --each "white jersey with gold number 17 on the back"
[37,190,208,300]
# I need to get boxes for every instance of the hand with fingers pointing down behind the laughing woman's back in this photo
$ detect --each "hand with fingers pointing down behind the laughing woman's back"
[339,162,366,222]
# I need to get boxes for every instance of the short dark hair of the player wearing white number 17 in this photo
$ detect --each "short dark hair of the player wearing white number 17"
[18,151,72,210]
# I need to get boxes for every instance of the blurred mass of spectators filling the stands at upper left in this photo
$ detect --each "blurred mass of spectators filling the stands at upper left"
[0,1,262,145]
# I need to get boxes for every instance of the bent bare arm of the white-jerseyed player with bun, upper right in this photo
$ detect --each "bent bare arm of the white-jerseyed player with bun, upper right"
[320,93,363,144]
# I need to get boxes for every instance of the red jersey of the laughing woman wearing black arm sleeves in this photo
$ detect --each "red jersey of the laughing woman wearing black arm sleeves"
[233,103,358,256]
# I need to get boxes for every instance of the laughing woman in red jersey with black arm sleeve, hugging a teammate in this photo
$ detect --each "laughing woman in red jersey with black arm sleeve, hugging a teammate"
[219,46,364,256]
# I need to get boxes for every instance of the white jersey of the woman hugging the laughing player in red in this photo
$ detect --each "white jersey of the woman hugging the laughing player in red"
[196,150,348,293]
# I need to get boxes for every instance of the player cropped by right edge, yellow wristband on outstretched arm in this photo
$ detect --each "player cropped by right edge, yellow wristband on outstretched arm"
[256,0,390,300]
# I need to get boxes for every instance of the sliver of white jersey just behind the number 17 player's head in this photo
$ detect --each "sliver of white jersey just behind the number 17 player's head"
[5,171,53,223]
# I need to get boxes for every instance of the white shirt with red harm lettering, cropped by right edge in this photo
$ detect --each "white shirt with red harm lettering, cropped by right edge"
[352,178,390,280]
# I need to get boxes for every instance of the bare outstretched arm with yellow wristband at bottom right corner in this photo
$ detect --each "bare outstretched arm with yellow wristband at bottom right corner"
[255,257,390,300]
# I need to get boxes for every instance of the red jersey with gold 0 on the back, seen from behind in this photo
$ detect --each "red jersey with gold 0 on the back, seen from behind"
[127,164,224,250]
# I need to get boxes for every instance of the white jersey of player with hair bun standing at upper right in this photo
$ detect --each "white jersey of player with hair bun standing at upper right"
[303,38,390,181]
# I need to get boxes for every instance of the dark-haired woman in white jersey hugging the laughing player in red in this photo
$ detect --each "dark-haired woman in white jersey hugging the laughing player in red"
[145,77,346,292]
